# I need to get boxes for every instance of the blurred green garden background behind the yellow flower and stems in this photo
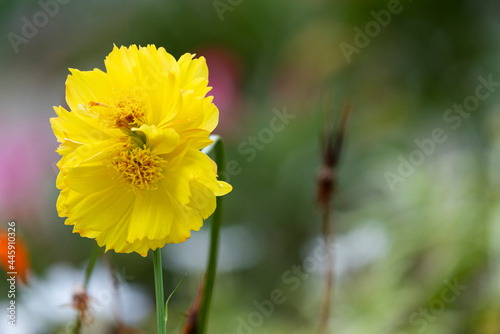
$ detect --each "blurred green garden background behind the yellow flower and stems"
[0,0,500,334]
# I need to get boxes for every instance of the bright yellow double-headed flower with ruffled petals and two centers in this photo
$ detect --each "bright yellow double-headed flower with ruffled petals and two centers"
[51,45,232,256]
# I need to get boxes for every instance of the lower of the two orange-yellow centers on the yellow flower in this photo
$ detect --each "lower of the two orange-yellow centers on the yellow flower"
[111,147,166,191]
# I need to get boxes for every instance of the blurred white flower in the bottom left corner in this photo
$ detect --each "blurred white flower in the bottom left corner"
[0,263,152,334]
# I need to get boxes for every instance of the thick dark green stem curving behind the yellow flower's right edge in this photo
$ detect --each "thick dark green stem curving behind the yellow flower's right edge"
[196,137,226,334]
